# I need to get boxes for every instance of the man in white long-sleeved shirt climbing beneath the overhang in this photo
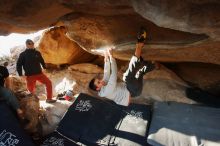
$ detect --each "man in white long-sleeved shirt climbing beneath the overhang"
[89,28,155,106]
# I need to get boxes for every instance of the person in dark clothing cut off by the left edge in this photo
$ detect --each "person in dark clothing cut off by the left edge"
[0,66,24,119]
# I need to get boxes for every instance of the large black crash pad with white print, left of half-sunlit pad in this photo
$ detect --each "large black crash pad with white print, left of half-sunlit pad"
[57,94,122,145]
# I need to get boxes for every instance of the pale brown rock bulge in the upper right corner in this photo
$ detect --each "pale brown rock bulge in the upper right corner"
[132,0,220,39]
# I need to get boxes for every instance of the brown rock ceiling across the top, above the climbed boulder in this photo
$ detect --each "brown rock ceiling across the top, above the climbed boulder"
[0,0,220,38]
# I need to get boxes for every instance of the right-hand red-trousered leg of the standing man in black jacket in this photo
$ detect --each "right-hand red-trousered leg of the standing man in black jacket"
[37,73,53,100]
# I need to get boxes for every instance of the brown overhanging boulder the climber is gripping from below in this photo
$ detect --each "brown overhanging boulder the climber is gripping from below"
[62,14,220,64]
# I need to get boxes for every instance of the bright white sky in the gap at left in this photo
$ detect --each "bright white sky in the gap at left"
[0,30,44,57]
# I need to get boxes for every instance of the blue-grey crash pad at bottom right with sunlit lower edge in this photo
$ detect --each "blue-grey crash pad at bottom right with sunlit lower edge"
[148,102,220,146]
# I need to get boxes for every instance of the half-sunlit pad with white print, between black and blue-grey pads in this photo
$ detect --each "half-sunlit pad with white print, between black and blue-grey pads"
[112,104,150,146]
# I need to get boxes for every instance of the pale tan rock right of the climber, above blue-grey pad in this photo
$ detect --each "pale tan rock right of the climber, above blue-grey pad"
[141,66,196,104]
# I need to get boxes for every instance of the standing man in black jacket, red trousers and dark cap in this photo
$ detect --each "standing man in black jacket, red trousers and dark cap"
[17,39,56,103]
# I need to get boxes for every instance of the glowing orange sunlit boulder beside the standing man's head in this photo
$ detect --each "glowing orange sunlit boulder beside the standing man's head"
[38,27,97,65]
